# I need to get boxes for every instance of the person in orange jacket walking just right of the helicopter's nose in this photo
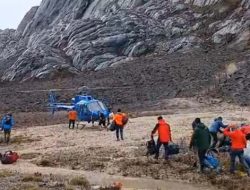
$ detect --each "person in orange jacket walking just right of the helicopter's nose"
[113,109,126,141]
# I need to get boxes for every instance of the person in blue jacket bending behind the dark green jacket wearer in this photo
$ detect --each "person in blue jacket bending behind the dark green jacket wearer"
[209,117,227,148]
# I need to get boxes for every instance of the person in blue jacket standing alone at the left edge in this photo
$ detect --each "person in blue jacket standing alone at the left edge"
[1,114,15,144]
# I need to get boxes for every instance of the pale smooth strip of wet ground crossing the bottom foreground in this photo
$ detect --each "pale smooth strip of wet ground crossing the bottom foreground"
[0,161,215,190]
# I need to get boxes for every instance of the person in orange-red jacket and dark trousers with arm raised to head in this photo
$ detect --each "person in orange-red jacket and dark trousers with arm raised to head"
[223,125,250,176]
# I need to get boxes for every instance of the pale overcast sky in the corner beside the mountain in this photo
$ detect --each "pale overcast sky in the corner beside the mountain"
[0,0,42,29]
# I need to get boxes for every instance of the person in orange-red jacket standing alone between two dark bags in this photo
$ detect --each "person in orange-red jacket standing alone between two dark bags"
[151,116,172,160]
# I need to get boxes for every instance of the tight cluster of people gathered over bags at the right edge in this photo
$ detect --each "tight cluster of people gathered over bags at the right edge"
[190,117,250,176]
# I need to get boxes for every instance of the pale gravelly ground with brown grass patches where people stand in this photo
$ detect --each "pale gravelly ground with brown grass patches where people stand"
[0,99,250,190]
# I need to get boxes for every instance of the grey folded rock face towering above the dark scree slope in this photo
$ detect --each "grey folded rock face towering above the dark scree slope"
[0,0,250,80]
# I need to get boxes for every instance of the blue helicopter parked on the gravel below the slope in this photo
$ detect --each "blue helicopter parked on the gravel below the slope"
[49,87,110,123]
